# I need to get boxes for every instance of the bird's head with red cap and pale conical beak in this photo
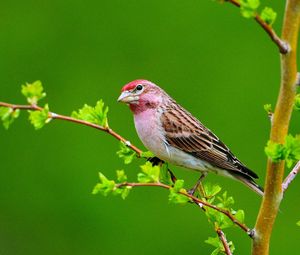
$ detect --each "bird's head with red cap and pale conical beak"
[118,80,163,113]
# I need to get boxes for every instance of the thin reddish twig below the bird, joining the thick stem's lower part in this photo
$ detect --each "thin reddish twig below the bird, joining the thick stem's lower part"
[116,182,253,235]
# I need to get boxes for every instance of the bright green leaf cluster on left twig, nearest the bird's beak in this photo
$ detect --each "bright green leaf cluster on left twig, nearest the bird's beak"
[72,100,108,128]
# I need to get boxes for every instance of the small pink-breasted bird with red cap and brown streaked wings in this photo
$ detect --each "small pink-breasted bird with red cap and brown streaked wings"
[118,80,263,195]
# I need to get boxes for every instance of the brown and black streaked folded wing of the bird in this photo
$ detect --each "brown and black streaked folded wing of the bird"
[161,104,257,178]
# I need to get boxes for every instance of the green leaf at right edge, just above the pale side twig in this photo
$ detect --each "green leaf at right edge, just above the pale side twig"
[284,135,300,168]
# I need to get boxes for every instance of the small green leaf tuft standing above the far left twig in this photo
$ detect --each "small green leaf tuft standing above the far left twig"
[21,81,46,105]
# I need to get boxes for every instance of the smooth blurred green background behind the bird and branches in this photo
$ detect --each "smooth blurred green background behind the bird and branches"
[0,0,300,255]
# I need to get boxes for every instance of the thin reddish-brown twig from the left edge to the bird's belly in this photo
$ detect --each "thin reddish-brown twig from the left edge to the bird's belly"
[0,102,142,157]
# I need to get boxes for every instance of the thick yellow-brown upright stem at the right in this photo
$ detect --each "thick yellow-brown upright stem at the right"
[252,0,300,255]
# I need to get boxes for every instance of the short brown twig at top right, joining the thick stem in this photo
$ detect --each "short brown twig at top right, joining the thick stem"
[225,0,290,54]
